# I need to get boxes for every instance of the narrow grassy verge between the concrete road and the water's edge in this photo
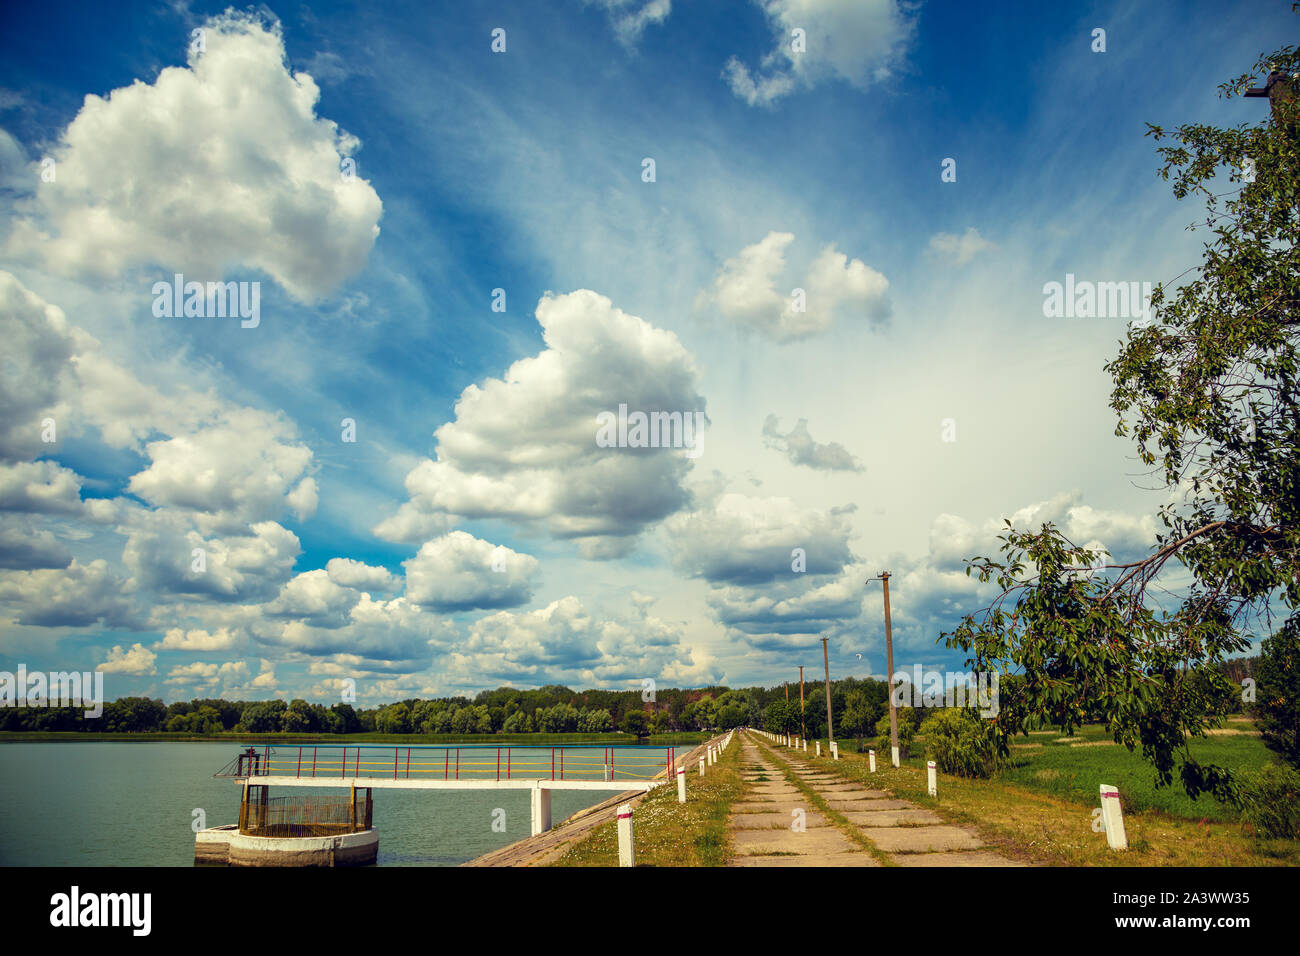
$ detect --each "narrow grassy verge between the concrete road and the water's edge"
[550,737,744,866]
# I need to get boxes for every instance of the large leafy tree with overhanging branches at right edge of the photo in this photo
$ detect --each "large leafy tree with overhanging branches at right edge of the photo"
[943,26,1300,797]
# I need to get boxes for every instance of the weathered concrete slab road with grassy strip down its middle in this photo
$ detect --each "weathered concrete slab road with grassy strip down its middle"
[731,734,1019,866]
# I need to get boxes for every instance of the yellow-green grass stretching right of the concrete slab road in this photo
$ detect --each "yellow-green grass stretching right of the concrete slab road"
[780,727,1300,866]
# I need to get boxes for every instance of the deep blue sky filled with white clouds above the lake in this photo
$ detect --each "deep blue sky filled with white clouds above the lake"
[0,0,1294,704]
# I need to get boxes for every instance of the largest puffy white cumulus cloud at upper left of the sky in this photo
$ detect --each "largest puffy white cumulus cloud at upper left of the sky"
[9,12,382,300]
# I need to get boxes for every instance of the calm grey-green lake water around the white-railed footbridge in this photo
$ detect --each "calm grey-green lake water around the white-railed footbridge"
[0,741,689,866]
